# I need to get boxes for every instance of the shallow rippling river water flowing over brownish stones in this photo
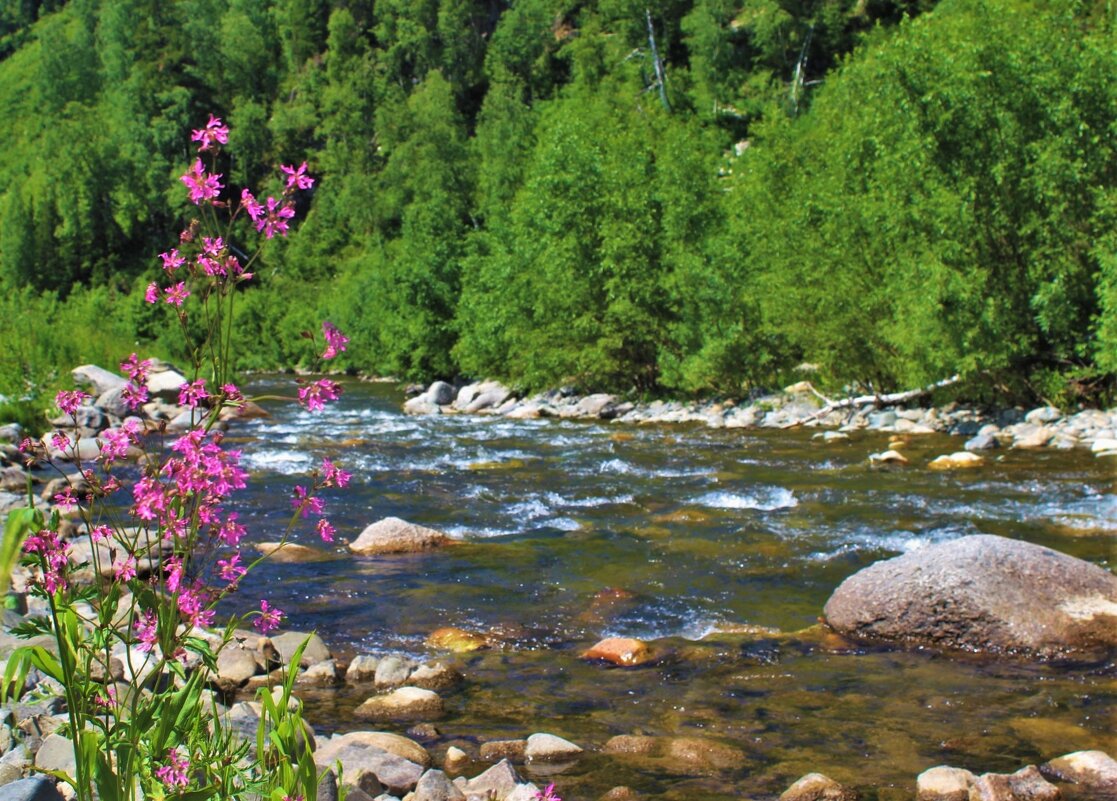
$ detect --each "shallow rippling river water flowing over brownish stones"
[222,378,1117,801]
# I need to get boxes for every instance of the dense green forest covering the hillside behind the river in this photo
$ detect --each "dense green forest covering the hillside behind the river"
[0,0,1117,404]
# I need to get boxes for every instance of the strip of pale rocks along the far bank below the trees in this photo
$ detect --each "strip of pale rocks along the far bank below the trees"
[403,381,1117,457]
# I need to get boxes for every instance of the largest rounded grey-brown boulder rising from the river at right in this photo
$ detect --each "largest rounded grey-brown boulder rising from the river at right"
[824,534,1117,657]
